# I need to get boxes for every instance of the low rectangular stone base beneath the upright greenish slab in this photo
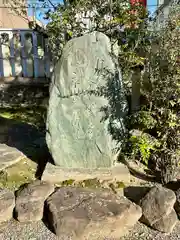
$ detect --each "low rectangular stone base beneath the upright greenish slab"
[41,163,130,183]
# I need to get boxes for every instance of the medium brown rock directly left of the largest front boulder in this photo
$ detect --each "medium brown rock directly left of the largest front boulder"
[15,180,54,222]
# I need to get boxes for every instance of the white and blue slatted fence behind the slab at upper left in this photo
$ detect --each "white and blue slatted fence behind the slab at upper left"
[0,28,51,78]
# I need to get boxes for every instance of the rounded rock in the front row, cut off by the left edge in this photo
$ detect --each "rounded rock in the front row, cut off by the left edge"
[0,189,15,224]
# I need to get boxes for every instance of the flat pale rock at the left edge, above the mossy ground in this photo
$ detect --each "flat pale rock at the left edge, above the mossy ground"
[0,144,24,171]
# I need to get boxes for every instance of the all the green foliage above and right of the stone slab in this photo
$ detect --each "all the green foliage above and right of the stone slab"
[3,0,180,183]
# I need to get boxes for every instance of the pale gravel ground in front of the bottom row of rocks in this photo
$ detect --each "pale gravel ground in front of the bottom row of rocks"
[0,220,180,240]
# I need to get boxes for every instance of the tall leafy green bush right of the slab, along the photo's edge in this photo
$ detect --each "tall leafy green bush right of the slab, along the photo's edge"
[122,6,180,183]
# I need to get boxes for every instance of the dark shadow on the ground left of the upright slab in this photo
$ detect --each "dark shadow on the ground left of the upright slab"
[0,117,52,178]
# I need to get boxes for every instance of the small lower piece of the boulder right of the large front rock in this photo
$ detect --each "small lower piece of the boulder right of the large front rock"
[152,209,178,233]
